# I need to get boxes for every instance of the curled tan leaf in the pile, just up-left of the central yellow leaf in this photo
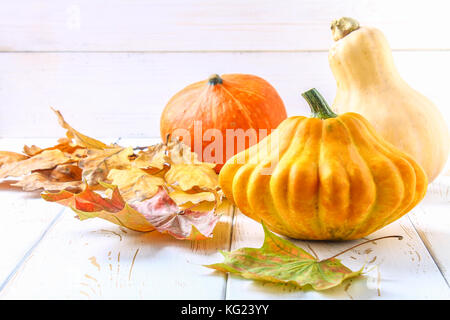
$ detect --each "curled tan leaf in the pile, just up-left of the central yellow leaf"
[78,147,134,185]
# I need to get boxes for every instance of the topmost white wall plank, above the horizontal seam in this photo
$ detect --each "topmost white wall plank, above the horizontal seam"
[0,0,450,51]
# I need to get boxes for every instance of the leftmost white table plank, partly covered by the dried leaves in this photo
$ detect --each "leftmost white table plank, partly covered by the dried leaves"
[0,139,67,289]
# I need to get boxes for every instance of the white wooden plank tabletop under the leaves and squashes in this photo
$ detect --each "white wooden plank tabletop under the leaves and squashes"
[0,139,450,299]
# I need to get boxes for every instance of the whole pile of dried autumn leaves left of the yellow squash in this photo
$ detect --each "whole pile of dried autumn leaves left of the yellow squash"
[0,110,222,240]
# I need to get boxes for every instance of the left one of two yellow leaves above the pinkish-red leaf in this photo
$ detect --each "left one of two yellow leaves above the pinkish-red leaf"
[107,168,165,203]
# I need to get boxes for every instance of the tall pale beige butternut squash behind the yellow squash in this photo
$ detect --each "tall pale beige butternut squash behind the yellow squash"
[328,18,450,182]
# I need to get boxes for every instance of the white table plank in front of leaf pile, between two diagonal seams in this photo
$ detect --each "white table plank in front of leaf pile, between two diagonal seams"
[0,202,236,299]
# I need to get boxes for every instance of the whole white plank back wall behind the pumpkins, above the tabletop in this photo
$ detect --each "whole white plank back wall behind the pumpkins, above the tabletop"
[0,0,450,137]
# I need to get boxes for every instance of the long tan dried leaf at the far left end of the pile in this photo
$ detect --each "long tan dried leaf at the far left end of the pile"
[0,149,74,179]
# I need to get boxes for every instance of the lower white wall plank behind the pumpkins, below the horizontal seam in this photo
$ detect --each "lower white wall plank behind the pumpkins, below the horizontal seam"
[0,51,450,138]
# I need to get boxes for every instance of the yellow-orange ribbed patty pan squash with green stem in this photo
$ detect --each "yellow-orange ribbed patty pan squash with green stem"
[219,89,428,240]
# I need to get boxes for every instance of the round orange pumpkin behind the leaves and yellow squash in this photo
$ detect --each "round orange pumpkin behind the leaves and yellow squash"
[160,74,287,171]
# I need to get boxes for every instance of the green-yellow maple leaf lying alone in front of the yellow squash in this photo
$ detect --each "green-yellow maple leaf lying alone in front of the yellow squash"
[205,224,363,290]
